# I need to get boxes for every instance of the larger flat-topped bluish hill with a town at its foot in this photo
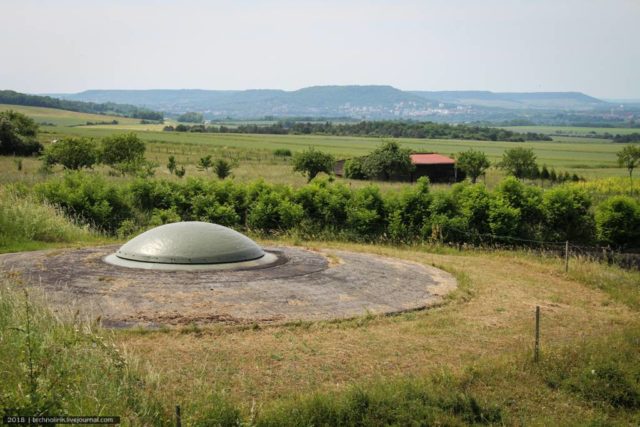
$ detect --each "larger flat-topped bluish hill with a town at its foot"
[56,86,438,118]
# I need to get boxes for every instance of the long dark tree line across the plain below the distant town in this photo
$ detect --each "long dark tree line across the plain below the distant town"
[164,121,552,142]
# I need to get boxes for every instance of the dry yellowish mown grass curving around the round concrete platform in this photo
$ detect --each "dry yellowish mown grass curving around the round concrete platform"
[117,242,640,425]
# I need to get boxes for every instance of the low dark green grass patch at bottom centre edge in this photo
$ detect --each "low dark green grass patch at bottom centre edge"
[256,374,502,427]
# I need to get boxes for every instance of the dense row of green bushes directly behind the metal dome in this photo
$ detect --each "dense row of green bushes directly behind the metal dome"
[35,172,640,248]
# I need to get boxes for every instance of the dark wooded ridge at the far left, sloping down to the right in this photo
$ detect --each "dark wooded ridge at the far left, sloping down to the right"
[0,90,164,122]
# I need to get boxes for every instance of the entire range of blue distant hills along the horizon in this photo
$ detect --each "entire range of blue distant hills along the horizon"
[48,86,610,122]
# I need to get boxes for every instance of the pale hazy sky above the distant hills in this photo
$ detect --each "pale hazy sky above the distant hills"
[0,0,640,99]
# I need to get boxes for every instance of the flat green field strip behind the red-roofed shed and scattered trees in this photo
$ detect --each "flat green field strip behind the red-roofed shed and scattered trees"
[48,127,626,178]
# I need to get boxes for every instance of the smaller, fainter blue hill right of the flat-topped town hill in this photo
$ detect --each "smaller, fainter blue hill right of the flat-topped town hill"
[410,91,608,111]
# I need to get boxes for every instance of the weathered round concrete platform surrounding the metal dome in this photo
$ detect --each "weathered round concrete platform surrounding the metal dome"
[0,246,456,327]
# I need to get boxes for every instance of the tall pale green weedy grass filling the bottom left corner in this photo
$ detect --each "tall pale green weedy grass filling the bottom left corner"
[0,278,167,425]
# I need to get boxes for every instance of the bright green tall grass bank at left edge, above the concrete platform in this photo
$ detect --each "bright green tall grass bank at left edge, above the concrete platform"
[0,187,92,249]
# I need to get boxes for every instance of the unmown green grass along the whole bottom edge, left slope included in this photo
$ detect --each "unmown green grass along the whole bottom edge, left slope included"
[0,276,640,426]
